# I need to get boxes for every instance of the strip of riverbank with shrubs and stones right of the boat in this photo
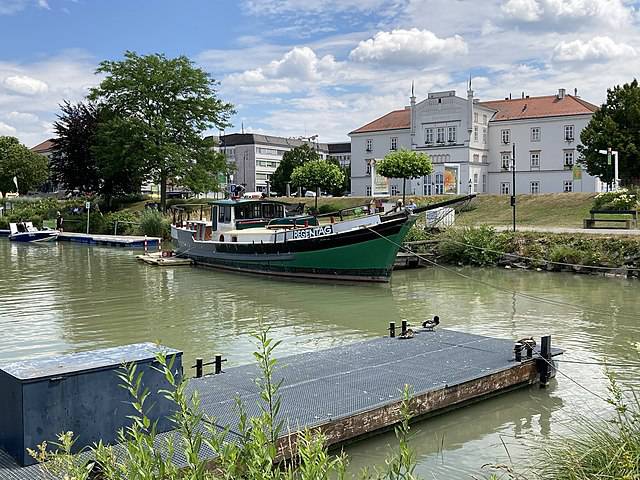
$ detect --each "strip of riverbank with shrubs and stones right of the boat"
[408,226,640,278]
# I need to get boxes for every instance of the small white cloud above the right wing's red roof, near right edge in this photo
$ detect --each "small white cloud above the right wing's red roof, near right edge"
[553,37,637,62]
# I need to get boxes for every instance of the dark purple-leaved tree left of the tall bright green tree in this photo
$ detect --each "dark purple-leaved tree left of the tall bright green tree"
[51,101,101,193]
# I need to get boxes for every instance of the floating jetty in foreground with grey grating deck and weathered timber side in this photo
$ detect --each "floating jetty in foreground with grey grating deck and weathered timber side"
[0,326,562,480]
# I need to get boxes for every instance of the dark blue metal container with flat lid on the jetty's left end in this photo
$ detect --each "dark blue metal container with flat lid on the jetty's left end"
[0,343,182,465]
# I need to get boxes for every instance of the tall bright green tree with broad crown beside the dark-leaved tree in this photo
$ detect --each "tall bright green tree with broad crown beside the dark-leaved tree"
[89,51,234,210]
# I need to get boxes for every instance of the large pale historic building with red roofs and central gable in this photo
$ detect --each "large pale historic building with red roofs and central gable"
[349,88,603,196]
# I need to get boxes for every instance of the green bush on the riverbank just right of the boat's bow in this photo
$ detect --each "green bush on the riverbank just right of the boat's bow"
[438,225,505,266]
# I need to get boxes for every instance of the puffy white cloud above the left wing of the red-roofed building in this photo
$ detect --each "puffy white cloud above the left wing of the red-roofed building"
[349,28,467,65]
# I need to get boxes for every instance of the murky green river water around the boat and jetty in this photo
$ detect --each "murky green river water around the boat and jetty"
[0,239,640,479]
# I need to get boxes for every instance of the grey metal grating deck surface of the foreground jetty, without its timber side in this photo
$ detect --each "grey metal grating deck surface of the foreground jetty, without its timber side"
[0,330,559,480]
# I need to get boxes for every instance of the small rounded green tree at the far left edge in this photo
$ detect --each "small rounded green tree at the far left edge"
[0,137,49,198]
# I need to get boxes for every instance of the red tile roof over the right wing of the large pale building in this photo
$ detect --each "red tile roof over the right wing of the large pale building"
[480,95,598,121]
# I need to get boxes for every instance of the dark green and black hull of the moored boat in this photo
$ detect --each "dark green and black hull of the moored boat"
[174,217,415,282]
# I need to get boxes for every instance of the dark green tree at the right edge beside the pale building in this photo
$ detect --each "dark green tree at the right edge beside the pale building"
[578,80,640,184]
